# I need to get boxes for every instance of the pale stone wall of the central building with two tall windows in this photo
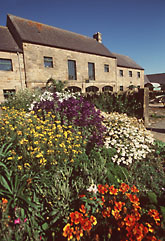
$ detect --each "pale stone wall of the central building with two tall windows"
[23,43,117,92]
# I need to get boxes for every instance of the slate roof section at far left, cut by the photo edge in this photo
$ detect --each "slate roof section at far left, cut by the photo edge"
[0,26,22,52]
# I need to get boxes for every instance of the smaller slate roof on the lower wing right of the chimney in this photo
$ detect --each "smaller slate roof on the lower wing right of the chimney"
[113,53,144,70]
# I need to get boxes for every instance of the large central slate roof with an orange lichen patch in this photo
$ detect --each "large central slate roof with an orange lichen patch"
[7,14,115,58]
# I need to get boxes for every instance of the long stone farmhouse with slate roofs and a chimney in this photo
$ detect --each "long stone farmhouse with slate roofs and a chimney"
[0,15,144,102]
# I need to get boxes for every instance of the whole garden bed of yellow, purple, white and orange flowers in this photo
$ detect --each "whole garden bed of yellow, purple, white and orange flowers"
[0,89,164,241]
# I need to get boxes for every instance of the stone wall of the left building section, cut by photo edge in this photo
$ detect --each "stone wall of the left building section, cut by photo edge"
[0,52,25,103]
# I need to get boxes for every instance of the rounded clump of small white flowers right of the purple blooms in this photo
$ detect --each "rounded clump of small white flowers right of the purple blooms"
[102,112,154,165]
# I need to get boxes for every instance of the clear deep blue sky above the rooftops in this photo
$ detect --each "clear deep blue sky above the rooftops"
[0,0,165,74]
